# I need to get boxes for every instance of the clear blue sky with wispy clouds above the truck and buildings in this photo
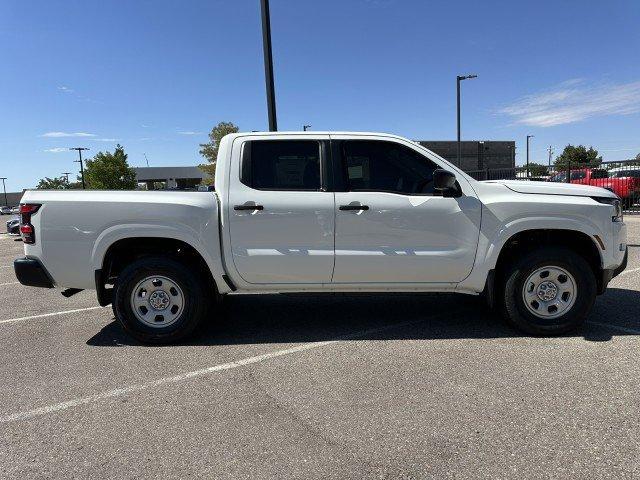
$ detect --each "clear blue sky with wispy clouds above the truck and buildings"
[0,0,640,191]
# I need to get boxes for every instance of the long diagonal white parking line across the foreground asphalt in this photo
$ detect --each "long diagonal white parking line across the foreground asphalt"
[0,312,461,423]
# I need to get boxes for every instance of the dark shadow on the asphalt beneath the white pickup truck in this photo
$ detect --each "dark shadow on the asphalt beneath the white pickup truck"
[87,288,640,347]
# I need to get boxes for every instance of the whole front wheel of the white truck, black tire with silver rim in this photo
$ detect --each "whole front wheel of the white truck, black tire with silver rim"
[501,247,597,335]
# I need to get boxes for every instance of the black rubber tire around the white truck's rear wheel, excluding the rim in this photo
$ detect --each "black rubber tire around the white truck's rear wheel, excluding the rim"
[113,257,209,344]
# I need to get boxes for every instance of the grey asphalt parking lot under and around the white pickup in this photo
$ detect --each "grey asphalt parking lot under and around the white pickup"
[0,216,640,479]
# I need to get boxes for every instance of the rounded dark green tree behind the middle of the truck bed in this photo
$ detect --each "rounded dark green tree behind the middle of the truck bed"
[84,144,136,190]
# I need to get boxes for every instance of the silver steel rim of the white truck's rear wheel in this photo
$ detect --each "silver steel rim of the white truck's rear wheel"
[131,275,184,328]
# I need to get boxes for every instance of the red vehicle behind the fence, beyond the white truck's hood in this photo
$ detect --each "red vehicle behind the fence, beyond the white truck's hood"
[549,168,640,208]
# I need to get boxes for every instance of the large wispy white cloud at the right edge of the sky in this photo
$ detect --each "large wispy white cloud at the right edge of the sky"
[498,79,640,127]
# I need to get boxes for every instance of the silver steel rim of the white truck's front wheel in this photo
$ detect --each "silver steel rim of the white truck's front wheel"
[522,265,578,320]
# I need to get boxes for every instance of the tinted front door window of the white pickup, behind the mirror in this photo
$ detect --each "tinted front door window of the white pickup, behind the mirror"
[342,140,438,195]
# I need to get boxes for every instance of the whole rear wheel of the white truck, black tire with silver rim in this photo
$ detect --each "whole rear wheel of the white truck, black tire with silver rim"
[113,257,206,344]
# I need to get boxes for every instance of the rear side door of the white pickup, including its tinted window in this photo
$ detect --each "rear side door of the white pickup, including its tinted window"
[227,135,335,284]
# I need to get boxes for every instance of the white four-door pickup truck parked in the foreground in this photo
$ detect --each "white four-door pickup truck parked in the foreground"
[15,132,627,343]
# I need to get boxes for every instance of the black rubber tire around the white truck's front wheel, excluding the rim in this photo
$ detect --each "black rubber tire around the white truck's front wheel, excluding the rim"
[498,247,597,336]
